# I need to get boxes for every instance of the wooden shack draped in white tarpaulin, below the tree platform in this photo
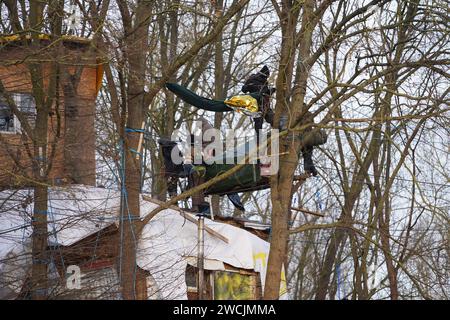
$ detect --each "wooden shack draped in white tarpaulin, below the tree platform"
[0,185,282,300]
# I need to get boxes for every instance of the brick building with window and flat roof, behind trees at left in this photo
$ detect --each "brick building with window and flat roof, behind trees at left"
[0,34,103,188]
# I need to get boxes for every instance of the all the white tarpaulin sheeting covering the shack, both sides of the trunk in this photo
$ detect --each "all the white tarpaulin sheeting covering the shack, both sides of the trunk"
[0,186,287,299]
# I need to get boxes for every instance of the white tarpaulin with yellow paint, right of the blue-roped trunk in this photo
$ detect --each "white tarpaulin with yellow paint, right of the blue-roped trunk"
[137,205,287,299]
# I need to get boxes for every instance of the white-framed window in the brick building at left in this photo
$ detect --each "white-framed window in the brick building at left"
[0,93,36,133]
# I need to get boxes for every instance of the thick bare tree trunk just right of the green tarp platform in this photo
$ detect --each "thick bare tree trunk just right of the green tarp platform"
[264,1,313,300]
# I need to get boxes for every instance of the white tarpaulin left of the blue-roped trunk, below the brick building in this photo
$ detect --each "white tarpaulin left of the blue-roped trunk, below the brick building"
[0,186,120,299]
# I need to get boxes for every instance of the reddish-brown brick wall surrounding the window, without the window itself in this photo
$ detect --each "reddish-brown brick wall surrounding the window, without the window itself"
[0,42,97,188]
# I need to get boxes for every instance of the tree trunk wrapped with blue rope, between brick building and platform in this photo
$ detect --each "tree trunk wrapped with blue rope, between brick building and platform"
[119,2,151,300]
